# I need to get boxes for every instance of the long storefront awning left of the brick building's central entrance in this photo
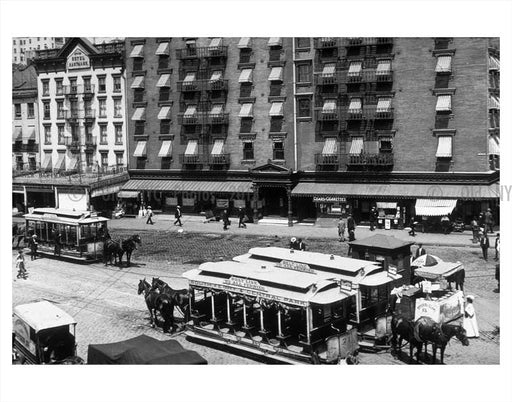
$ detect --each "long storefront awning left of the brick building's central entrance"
[123,179,253,194]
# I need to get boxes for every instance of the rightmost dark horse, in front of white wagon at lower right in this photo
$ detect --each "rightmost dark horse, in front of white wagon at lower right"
[414,317,469,364]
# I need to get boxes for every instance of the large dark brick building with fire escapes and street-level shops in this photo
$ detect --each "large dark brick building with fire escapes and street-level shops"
[117,38,499,226]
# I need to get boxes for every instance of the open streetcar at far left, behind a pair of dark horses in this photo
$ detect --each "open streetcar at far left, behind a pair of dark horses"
[24,208,108,261]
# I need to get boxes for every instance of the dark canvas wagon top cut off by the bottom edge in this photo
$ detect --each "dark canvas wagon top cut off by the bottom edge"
[87,335,208,364]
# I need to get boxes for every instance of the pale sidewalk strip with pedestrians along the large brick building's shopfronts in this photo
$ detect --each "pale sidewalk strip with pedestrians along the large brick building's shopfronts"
[109,215,497,249]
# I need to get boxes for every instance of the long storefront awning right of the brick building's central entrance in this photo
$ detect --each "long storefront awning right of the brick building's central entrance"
[292,182,500,201]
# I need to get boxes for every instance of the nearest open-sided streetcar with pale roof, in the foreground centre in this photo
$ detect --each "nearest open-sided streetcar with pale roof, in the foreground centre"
[183,261,358,364]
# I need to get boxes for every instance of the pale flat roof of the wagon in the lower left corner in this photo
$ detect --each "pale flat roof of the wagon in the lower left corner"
[14,301,76,332]
